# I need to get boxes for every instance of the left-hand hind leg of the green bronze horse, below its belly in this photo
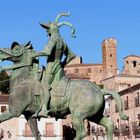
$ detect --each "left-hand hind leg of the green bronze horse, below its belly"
[72,116,88,140]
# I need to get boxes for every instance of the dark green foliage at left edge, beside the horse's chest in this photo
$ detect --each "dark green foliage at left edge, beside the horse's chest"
[0,70,10,94]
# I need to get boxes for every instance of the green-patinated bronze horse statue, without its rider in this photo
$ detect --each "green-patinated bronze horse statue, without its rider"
[0,42,127,140]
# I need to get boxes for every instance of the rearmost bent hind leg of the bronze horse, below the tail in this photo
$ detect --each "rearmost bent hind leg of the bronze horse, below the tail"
[99,117,114,140]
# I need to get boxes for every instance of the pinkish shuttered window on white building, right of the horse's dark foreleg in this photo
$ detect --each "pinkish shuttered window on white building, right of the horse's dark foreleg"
[45,123,54,137]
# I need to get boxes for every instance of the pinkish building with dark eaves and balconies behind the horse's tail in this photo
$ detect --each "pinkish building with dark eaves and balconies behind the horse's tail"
[108,83,140,140]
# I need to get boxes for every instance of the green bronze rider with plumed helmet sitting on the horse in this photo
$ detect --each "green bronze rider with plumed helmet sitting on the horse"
[34,13,75,117]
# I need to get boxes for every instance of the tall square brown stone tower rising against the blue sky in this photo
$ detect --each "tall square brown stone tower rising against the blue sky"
[102,38,117,79]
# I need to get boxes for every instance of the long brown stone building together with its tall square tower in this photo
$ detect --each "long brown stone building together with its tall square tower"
[65,38,117,85]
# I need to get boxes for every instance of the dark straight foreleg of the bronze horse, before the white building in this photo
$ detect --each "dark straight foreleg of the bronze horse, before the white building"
[27,117,41,140]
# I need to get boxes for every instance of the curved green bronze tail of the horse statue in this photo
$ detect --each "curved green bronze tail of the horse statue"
[102,90,128,120]
